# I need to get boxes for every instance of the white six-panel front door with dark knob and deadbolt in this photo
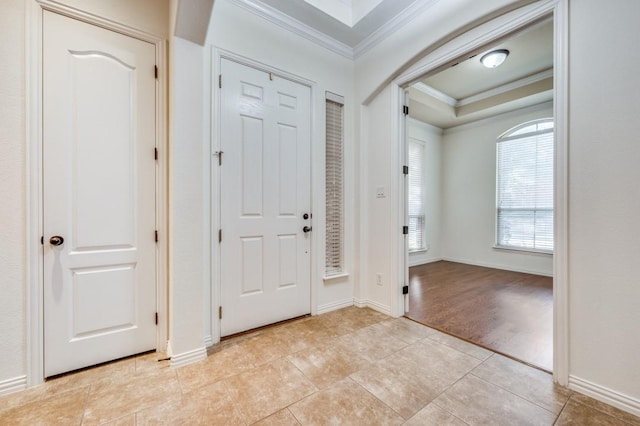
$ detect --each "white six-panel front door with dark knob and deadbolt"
[220,59,311,336]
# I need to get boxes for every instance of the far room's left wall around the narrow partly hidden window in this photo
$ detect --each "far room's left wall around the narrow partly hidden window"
[407,118,442,266]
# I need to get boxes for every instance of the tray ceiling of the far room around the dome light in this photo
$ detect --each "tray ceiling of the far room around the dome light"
[409,20,553,129]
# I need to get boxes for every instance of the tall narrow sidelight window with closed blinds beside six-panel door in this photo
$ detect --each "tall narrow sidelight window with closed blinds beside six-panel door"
[325,93,344,277]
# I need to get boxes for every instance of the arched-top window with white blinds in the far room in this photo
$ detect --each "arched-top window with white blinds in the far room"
[496,119,553,252]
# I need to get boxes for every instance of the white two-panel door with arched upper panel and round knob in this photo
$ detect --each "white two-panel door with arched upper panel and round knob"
[42,11,156,377]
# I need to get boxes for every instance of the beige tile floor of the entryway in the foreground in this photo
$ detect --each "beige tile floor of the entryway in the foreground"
[0,308,640,426]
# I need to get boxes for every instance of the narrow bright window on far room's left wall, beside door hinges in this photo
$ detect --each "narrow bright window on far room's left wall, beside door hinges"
[408,139,425,252]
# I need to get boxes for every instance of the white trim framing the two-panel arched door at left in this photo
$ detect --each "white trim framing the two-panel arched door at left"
[25,0,169,386]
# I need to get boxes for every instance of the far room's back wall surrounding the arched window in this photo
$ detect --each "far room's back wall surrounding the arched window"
[442,104,553,276]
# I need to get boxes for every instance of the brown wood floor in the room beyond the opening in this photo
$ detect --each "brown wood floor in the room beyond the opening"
[406,261,553,371]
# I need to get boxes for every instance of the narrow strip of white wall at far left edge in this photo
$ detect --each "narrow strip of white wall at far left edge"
[0,1,26,389]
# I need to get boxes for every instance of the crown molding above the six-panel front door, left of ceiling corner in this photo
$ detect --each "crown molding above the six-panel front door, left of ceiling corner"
[229,0,354,59]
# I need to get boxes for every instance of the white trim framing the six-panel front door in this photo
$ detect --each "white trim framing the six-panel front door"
[209,46,324,345]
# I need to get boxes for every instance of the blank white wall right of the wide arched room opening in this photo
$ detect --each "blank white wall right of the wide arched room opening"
[569,0,640,406]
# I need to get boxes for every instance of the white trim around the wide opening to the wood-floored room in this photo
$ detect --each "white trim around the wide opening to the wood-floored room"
[390,0,569,386]
